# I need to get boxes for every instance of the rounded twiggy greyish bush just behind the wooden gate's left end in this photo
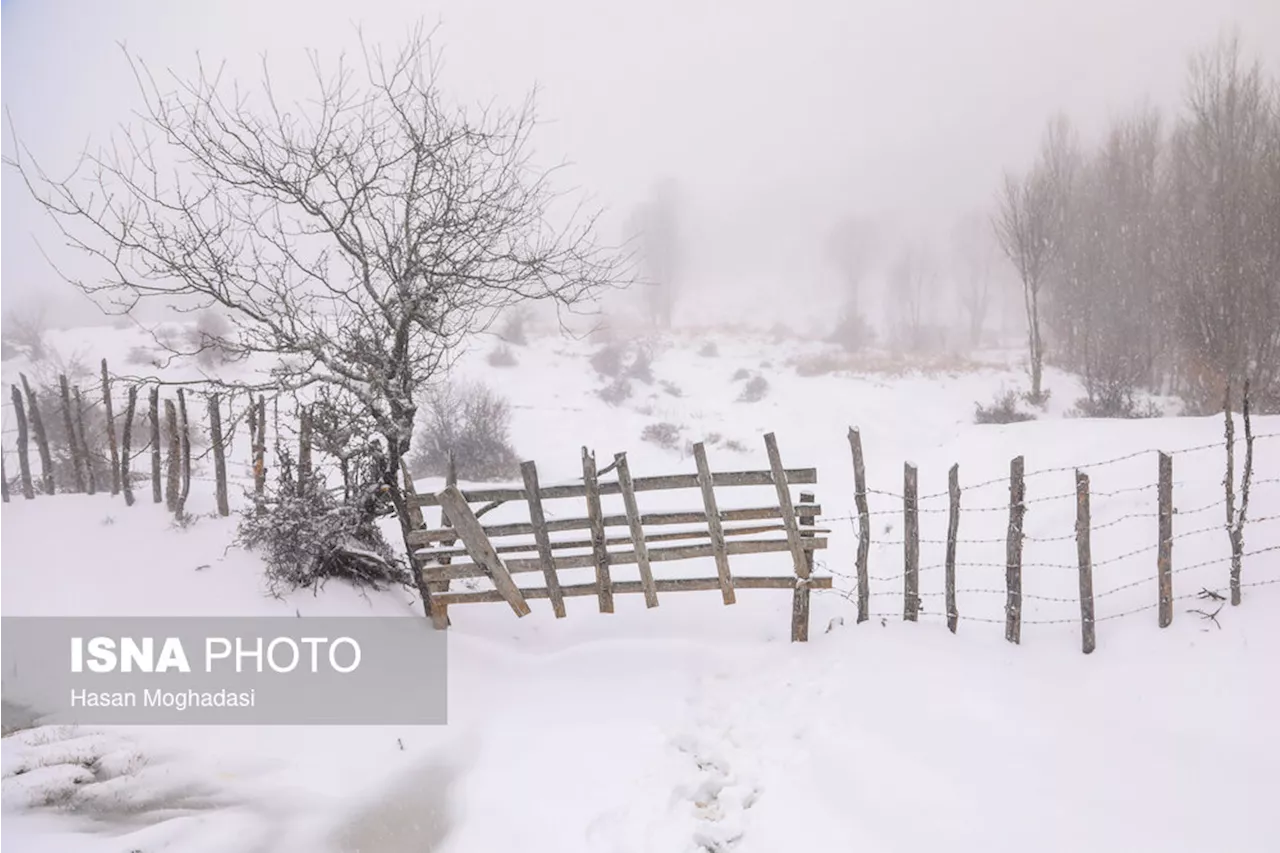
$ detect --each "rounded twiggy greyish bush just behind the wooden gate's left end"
[410,383,520,480]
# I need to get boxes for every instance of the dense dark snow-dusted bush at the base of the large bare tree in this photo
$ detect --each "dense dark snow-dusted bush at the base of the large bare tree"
[237,453,410,594]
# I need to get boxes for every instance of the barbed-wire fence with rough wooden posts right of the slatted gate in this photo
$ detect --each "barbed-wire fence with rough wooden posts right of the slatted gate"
[839,401,1280,654]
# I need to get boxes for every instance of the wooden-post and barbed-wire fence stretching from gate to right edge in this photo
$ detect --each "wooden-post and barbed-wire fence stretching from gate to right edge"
[818,401,1280,653]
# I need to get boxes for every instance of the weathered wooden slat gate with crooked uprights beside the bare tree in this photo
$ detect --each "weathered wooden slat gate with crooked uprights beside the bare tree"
[408,433,831,642]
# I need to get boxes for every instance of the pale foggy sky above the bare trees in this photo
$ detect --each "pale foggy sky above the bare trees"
[0,0,1280,325]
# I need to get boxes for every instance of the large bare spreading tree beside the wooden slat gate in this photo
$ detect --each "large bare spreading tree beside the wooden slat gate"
[8,28,617,535]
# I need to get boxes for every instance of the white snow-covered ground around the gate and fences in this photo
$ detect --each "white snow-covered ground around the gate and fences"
[0,322,1280,853]
